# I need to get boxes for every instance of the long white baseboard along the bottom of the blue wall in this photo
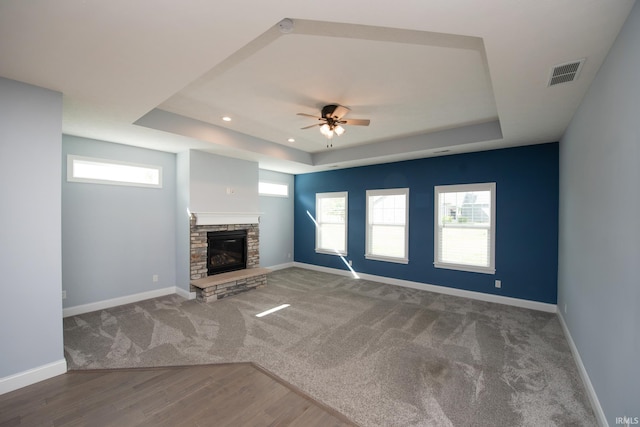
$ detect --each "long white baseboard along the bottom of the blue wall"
[293,262,558,313]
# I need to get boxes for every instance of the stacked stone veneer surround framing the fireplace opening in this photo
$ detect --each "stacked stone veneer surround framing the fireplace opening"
[190,216,260,280]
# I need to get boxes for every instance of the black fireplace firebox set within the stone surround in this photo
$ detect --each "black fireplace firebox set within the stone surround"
[207,230,247,276]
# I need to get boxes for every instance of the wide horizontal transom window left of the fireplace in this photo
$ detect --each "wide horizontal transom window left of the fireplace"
[67,155,162,188]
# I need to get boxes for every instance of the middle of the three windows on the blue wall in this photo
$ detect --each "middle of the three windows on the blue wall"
[365,188,409,264]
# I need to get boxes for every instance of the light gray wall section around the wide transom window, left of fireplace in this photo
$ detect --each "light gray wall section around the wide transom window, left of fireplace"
[58,135,176,307]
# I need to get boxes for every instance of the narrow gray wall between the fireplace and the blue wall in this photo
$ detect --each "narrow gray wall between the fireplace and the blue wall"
[259,169,294,267]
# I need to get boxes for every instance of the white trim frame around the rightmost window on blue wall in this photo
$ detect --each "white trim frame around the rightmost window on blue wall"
[433,182,496,274]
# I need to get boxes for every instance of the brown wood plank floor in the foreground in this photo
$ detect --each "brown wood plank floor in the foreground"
[0,363,355,427]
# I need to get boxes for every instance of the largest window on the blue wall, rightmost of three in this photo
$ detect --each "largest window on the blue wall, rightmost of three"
[433,182,496,274]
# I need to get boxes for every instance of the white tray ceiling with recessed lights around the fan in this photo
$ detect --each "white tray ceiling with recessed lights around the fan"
[0,0,633,173]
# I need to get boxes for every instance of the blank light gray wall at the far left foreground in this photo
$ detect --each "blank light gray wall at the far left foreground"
[0,78,64,378]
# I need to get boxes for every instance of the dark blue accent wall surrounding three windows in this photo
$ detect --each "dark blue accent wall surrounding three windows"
[294,143,559,304]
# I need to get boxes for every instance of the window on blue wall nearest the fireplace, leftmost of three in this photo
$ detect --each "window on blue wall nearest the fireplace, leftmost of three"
[316,191,347,255]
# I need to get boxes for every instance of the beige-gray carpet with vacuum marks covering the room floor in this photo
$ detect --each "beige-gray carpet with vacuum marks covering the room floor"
[64,268,597,426]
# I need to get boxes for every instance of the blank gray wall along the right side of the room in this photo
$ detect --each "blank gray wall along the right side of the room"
[558,3,640,425]
